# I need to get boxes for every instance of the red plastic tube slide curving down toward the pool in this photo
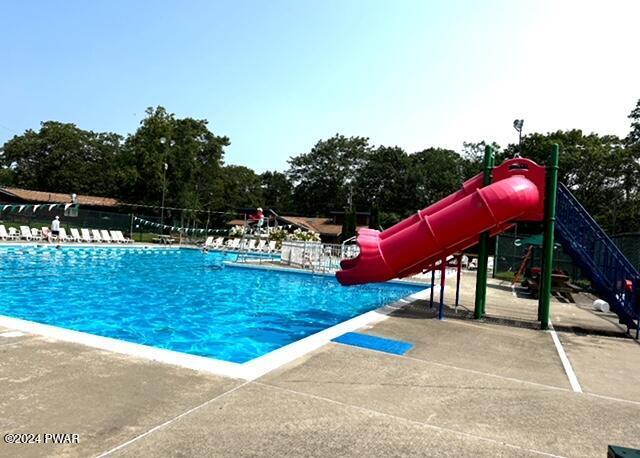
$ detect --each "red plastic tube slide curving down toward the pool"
[336,158,545,285]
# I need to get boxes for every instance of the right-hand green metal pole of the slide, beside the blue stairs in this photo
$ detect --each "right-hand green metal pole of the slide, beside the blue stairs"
[538,144,560,329]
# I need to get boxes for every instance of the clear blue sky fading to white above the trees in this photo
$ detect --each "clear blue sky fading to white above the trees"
[0,0,640,171]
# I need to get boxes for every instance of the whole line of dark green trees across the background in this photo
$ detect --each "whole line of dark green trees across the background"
[0,100,640,233]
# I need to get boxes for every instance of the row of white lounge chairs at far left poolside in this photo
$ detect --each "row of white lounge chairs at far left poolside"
[0,224,133,243]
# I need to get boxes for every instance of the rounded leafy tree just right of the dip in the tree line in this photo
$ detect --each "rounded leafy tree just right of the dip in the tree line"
[287,134,371,215]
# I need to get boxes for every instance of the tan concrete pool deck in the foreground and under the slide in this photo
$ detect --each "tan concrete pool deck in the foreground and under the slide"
[0,273,640,457]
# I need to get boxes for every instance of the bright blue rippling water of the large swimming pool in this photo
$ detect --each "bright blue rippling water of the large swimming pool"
[0,247,422,363]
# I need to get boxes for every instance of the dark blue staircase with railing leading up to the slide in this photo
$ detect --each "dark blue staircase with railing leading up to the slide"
[556,184,640,338]
